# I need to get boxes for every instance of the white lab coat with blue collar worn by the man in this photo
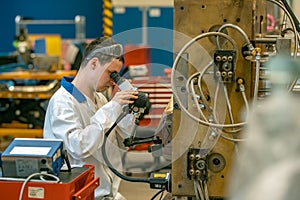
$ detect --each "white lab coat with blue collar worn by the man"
[44,76,134,199]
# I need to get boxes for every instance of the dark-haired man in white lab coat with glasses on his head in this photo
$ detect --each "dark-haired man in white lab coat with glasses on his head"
[44,38,138,200]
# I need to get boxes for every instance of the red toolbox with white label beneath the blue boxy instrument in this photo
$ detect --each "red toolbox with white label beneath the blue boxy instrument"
[0,165,99,200]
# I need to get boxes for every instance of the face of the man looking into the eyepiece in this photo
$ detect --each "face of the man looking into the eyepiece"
[96,59,123,92]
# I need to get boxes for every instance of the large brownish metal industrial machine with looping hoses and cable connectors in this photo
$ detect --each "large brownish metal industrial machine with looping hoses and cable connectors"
[168,0,299,200]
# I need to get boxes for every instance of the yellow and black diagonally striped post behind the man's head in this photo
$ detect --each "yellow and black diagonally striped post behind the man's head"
[103,0,113,37]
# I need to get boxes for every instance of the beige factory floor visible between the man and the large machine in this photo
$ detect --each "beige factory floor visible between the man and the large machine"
[119,152,170,200]
